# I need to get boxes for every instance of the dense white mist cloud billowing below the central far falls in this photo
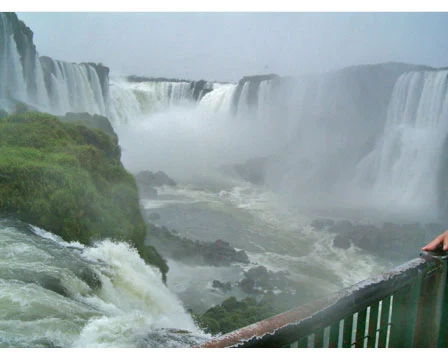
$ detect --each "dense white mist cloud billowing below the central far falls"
[116,81,287,181]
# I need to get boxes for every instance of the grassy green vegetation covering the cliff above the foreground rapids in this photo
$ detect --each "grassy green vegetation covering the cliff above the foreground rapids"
[0,112,168,281]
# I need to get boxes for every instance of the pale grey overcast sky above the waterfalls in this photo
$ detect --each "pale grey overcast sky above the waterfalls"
[18,12,448,82]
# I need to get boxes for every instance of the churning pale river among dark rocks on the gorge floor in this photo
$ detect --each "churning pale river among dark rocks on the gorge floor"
[138,180,390,312]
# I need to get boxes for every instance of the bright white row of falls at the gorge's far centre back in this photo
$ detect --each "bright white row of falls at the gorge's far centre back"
[110,78,284,126]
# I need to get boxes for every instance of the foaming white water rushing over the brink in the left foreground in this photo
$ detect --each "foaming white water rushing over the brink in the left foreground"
[0,219,209,347]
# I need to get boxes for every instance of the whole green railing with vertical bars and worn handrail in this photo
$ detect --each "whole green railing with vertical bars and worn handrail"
[202,252,448,348]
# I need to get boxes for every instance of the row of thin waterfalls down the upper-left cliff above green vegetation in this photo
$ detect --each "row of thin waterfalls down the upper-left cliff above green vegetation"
[0,13,108,115]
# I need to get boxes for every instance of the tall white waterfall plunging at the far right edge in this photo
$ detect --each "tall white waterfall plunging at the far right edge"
[357,71,448,218]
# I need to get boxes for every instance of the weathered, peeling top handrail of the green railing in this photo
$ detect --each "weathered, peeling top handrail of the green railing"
[201,254,443,348]
